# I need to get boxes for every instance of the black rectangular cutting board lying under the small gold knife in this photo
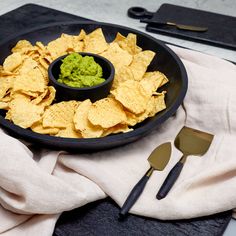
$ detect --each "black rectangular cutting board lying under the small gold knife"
[145,4,236,50]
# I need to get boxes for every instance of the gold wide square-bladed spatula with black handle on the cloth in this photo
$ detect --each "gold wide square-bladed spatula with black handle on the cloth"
[156,126,214,200]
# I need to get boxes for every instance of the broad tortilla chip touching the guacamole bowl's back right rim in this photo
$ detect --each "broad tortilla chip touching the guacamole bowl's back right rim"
[101,43,133,70]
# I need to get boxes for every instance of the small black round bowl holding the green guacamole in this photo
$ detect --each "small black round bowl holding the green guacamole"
[48,52,115,102]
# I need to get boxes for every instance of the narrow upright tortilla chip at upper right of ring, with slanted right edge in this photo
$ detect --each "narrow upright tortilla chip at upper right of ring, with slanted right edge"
[130,50,155,81]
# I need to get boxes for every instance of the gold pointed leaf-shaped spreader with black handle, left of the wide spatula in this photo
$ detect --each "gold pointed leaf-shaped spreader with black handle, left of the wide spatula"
[120,142,171,217]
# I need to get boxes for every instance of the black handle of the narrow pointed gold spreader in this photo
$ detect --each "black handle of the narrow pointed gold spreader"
[119,173,149,217]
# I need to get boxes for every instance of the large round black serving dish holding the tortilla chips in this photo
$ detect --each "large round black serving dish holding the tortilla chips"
[0,22,188,151]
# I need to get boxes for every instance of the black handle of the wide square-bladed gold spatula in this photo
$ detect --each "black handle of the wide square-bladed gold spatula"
[156,161,184,200]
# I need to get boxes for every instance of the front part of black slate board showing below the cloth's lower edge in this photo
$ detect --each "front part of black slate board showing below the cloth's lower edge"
[54,198,231,236]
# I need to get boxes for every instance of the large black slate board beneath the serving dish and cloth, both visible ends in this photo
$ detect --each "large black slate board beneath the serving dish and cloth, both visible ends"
[0,4,231,236]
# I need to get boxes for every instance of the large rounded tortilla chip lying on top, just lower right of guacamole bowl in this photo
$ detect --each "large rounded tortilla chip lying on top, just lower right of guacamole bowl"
[111,80,150,114]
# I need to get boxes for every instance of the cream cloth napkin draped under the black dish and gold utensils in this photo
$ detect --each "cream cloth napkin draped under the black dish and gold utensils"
[0,46,236,236]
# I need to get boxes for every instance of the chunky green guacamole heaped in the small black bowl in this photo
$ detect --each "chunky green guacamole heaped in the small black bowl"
[57,53,105,88]
